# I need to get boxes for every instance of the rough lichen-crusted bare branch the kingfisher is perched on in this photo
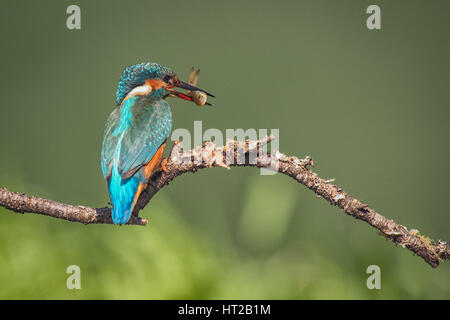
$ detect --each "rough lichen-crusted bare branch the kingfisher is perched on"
[0,136,450,268]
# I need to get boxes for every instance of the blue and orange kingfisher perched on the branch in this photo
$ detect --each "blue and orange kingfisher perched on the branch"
[101,62,214,225]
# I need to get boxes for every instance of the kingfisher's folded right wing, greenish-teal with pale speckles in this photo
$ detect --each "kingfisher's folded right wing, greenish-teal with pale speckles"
[119,100,172,179]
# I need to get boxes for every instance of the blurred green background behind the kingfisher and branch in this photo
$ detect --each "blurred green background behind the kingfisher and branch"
[0,0,450,299]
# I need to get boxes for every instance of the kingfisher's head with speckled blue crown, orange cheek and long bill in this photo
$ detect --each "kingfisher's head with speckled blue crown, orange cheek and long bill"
[116,62,214,106]
